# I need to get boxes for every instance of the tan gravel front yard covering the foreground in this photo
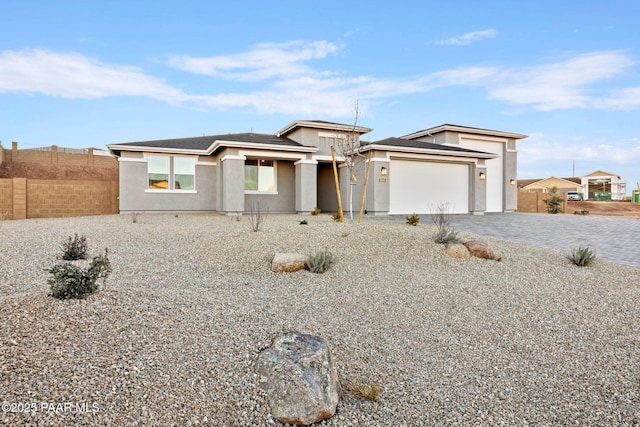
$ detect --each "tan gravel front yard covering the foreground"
[0,214,640,426]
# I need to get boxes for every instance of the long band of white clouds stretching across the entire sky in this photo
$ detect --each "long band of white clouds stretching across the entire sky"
[0,41,640,117]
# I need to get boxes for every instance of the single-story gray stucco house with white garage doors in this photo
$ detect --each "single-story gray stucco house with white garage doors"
[108,120,526,215]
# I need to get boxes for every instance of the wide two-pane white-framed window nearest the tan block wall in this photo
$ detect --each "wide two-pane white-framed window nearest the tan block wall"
[147,156,196,190]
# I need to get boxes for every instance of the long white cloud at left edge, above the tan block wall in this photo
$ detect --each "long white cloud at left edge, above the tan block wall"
[0,49,189,102]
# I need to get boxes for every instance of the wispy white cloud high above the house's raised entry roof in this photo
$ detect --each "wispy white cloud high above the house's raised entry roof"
[168,40,341,82]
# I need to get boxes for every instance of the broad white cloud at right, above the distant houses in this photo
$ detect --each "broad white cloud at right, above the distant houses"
[487,51,639,111]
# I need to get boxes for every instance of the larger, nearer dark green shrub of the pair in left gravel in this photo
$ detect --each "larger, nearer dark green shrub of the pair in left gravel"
[47,249,111,299]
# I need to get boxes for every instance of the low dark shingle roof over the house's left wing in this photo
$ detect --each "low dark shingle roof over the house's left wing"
[109,133,303,151]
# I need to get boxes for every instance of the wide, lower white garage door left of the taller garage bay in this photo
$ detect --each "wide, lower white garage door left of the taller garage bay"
[389,160,469,214]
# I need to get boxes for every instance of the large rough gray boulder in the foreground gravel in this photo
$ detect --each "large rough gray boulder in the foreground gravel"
[256,332,339,425]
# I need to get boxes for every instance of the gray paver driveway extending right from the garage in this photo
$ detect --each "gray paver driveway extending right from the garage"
[444,213,640,268]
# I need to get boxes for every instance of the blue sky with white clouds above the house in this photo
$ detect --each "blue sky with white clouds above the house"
[0,0,640,192]
